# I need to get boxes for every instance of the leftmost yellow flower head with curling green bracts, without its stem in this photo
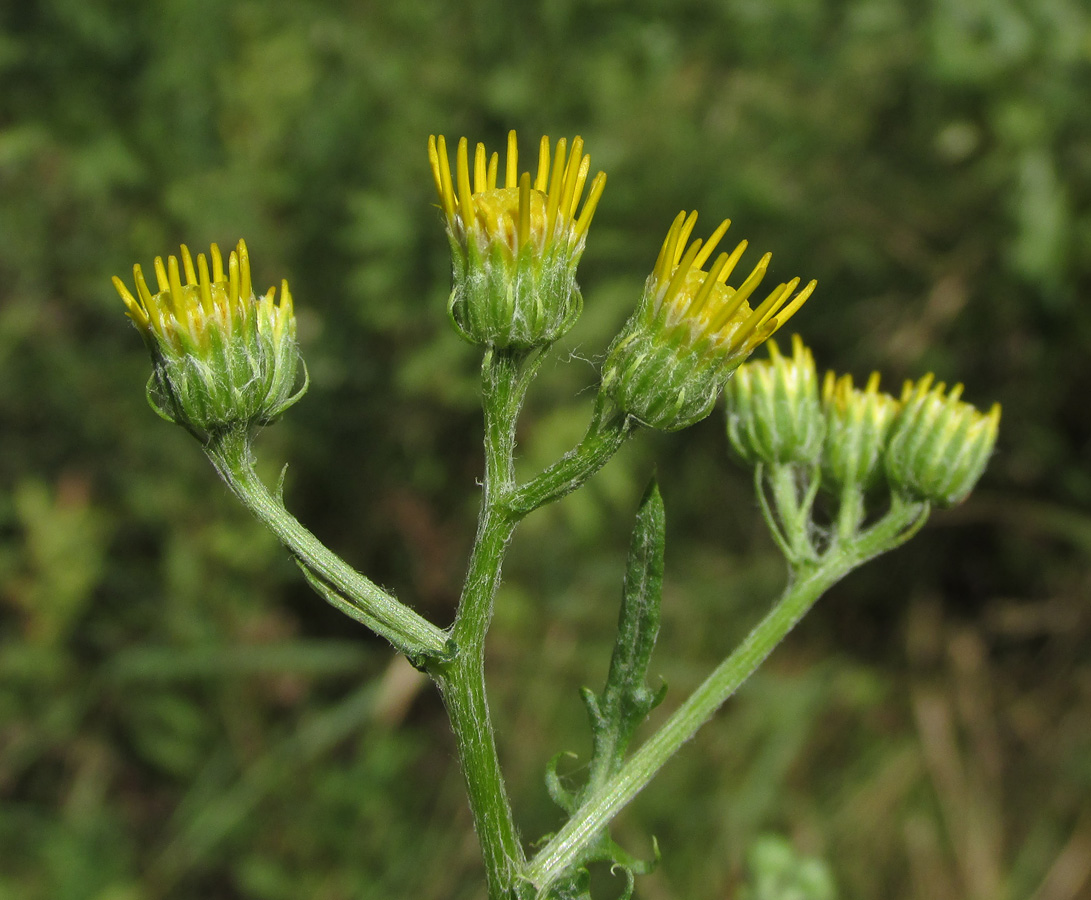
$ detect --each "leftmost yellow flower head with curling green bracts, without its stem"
[113,241,307,441]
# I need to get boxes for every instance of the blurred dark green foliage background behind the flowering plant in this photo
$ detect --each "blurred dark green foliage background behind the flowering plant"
[0,0,1091,900]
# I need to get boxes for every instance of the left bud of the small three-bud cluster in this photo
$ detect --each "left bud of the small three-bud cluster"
[724,335,825,466]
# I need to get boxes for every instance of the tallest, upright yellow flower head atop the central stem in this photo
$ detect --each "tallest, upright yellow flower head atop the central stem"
[428,131,607,348]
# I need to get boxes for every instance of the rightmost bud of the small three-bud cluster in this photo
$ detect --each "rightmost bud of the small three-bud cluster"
[885,374,1000,506]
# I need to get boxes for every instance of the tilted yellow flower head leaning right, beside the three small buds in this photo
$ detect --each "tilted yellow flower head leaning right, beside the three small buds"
[602,213,815,431]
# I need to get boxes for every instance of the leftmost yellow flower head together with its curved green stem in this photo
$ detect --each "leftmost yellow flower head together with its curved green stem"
[113,241,447,656]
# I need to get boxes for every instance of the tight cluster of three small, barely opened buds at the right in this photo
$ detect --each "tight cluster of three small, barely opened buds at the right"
[726,336,1000,506]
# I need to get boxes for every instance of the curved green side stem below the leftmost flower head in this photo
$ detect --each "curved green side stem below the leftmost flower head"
[205,429,449,663]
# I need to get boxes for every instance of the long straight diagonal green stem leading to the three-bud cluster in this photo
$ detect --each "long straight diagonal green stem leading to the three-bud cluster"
[526,501,927,896]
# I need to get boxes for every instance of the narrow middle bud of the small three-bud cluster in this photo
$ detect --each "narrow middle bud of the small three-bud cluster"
[822,372,899,490]
